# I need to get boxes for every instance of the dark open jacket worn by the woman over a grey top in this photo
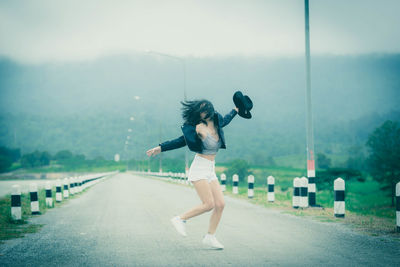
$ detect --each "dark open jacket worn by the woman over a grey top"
[160,109,237,153]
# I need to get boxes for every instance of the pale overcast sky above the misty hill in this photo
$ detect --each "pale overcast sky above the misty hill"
[0,0,400,63]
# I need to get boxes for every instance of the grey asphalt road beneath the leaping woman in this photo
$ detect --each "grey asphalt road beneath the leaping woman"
[0,174,400,266]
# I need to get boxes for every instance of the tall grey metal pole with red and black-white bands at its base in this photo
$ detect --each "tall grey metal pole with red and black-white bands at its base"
[304,0,316,206]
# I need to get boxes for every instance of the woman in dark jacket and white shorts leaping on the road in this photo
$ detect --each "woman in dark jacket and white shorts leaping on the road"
[146,99,239,249]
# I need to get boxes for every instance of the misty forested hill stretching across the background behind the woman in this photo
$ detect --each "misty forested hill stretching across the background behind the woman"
[0,55,400,168]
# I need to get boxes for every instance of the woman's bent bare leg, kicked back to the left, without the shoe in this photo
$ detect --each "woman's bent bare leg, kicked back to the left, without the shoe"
[180,179,214,220]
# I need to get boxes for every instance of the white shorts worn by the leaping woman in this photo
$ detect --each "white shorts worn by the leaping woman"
[188,154,218,183]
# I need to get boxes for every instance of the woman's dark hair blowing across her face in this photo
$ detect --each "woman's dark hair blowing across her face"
[181,99,215,125]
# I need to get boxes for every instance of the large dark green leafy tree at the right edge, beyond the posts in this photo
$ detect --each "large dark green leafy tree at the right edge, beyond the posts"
[367,120,400,206]
